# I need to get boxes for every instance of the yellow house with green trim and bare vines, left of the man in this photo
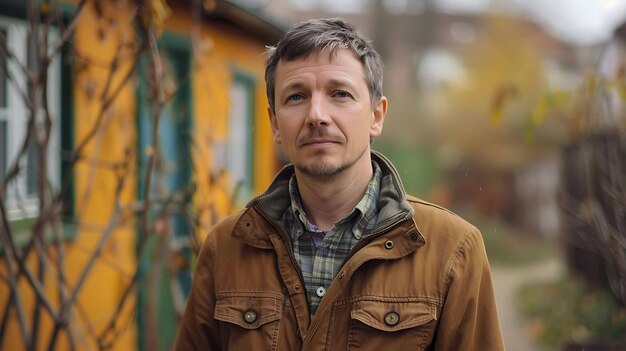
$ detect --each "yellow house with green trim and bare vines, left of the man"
[0,0,282,350]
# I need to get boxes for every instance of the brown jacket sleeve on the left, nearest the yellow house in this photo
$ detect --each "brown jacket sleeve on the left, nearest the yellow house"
[174,233,221,351]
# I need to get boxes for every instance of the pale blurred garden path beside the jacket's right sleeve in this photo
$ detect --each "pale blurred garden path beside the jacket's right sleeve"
[491,258,563,351]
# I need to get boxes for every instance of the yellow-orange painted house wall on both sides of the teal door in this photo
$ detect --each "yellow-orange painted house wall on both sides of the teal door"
[0,2,277,350]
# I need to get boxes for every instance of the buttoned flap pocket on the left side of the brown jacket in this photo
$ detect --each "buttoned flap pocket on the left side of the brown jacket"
[213,292,284,350]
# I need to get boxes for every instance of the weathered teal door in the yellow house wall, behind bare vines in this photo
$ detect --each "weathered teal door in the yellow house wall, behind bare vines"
[137,35,191,350]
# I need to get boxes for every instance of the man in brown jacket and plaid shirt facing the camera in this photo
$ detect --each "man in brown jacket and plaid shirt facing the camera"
[176,19,504,351]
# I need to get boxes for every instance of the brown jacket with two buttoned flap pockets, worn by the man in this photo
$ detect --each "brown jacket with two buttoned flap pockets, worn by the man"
[175,154,504,351]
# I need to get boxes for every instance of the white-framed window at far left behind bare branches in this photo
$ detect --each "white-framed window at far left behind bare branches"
[0,16,60,219]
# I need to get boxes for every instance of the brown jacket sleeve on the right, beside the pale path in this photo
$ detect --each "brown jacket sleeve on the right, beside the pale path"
[435,228,504,351]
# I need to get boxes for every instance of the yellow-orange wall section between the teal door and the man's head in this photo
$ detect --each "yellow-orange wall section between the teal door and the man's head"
[166,4,277,237]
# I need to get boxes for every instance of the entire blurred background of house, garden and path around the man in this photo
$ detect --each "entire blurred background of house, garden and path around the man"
[0,0,626,351]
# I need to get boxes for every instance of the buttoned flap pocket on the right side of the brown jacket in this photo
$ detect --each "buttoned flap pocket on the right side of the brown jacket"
[348,300,437,350]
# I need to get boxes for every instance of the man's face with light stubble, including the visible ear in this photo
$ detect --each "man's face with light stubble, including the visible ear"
[268,49,387,179]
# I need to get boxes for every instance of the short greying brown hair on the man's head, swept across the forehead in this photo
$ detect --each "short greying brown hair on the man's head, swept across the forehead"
[265,18,383,110]
